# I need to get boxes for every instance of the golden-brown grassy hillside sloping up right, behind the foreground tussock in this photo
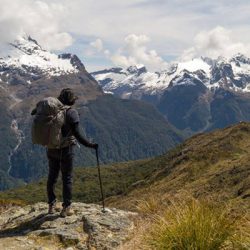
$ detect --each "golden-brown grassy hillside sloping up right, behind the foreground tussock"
[110,122,250,209]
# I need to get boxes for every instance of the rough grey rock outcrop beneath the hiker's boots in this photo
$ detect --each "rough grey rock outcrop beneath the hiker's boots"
[0,203,136,250]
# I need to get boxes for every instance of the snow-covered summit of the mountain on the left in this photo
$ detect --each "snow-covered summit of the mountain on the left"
[0,36,87,84]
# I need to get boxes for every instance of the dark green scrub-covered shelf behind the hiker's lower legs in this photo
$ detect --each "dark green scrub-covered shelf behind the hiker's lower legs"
[0,160,155,204]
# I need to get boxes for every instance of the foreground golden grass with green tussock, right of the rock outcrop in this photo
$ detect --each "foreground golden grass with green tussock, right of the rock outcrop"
[118,192,250,250]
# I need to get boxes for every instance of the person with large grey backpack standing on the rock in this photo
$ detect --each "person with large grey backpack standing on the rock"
[31,88,98,217]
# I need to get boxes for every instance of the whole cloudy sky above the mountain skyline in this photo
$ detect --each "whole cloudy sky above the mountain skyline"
[0,0,250,72]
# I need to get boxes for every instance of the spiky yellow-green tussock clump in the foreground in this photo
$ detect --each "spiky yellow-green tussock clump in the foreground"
[145,199,247,250]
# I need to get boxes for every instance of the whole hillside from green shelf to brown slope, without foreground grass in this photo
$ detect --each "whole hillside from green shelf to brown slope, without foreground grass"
[0,123,250,209]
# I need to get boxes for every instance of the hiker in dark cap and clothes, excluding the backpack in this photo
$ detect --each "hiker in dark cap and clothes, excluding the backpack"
[31,88,98,217]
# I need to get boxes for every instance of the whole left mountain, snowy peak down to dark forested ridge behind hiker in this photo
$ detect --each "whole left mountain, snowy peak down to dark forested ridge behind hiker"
[0,36,183,190]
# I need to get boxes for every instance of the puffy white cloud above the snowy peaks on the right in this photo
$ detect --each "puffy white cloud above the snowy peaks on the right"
[181,26,250,60]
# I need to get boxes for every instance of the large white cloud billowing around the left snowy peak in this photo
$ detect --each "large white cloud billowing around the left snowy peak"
[0,0,73,50]
